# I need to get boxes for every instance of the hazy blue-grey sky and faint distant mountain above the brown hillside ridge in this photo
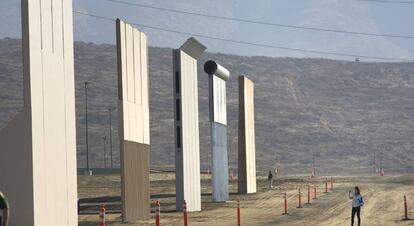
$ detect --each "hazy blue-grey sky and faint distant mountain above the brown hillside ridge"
[0,0,414,60]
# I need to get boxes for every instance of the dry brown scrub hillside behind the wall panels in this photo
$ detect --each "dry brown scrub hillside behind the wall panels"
[0,39,414,173]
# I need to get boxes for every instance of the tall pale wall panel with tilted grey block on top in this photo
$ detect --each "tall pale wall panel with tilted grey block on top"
[173,38,205,211]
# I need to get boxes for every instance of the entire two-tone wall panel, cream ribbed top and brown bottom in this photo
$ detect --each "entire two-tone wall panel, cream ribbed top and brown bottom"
[116,19,150,222]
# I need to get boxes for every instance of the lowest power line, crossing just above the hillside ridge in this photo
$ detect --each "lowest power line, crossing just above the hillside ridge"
[73,10,414,62]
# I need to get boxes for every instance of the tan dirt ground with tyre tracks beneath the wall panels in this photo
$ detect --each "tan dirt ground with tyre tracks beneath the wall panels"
[78,173,414,226]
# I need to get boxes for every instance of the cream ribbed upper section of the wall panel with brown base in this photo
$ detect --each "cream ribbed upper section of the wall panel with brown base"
[118,20,150,144]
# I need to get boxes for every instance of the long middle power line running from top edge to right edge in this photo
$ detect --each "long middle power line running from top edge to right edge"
[99,0,414,39]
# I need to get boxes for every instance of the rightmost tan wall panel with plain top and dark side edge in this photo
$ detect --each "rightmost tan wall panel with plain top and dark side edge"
[238,76,256,194]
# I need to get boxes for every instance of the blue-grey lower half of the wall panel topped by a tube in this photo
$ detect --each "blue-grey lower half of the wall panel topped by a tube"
[211,122,229,202]
